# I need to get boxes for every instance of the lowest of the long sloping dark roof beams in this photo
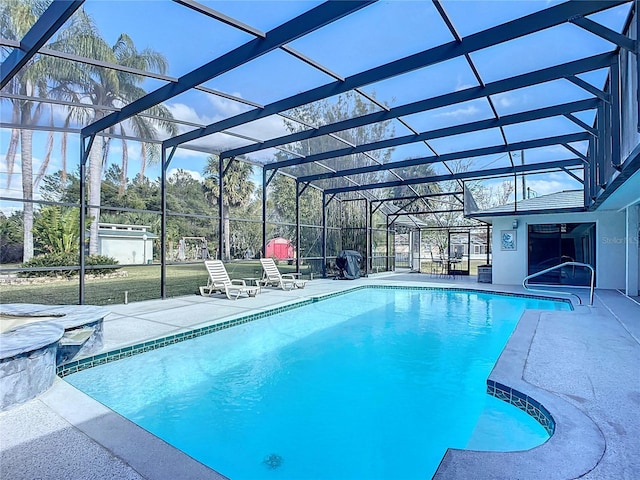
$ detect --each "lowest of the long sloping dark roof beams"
[325,158,584,194]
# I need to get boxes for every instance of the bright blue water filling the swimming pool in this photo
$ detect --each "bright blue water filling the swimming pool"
[65,289,568,480]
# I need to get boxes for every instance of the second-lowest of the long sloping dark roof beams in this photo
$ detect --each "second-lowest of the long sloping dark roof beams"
[299,133,591,182]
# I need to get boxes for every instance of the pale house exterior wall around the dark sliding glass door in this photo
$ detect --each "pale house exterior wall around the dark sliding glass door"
[492,210,626,288]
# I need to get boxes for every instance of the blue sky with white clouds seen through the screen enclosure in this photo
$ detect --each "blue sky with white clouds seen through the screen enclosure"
[0,0,629,210]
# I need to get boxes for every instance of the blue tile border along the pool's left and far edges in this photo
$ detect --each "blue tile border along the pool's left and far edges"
[57,285,573,388]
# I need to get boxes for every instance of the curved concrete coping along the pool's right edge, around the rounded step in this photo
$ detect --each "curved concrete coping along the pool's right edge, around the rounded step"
[433,310,606,480]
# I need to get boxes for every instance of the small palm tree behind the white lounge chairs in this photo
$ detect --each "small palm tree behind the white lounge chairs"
[204,155,255,261]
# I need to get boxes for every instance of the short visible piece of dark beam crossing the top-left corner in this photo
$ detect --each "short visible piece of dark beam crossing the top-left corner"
[0,0,84,88]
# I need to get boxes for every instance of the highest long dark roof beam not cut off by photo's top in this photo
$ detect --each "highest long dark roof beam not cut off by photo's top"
[231,53,616,161]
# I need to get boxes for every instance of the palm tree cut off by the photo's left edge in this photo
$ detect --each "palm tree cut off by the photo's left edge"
[0,0,49,262]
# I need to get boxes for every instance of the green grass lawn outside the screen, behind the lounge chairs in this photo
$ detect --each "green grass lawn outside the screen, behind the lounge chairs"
[0,260,314,305]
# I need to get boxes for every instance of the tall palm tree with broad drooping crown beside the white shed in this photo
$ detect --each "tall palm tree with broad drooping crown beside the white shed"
[51,10,177,254]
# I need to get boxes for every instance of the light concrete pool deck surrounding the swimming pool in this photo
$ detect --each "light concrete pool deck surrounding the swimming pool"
[0,273,640,480]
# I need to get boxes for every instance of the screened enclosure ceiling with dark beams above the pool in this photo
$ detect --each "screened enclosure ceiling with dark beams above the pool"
[0,0,636,210]
